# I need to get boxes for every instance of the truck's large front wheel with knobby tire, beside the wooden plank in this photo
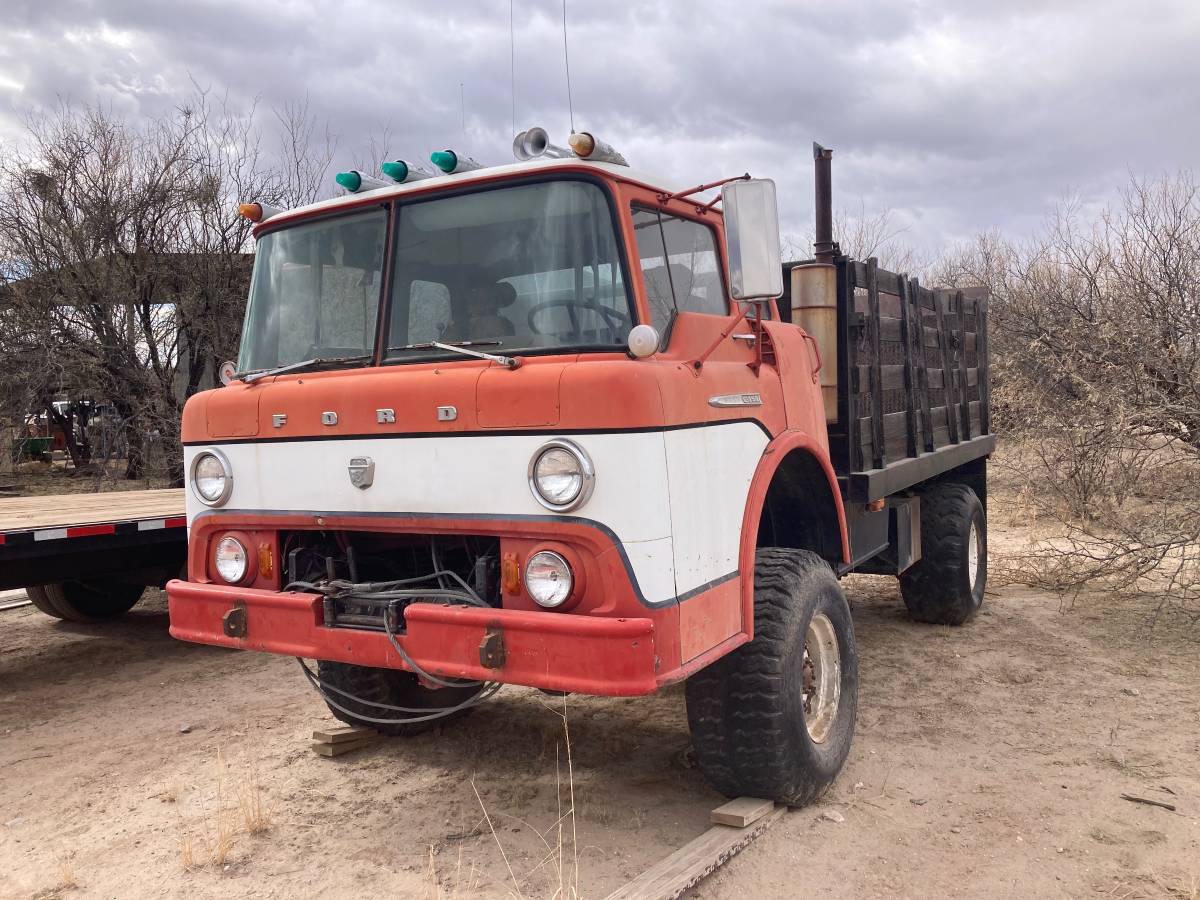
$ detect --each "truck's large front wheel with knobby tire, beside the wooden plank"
[686,547,858,806]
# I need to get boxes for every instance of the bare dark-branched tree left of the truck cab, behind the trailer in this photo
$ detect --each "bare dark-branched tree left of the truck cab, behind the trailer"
[0,91,283,481]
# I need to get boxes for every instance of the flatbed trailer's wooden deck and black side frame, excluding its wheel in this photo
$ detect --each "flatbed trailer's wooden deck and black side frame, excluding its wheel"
[0,488,187,590]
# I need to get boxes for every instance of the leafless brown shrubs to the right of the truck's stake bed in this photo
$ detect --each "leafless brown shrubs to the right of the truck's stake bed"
[937,172,1200,619]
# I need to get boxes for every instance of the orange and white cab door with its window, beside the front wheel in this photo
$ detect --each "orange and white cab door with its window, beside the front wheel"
[629,192,786,664]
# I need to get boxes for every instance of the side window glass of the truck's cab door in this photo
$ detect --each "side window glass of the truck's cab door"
[632,206,728,331]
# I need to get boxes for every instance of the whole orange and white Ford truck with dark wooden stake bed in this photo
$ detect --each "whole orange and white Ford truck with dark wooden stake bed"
[167,128,995,804]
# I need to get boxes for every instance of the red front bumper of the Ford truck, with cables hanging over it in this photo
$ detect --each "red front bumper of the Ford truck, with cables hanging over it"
[167,581,659,696]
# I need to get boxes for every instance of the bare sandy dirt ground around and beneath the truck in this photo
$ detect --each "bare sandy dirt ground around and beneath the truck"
[0,494,1200,900]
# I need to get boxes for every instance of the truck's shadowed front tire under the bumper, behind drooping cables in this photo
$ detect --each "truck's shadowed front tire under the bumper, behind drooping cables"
[317,660,479,737]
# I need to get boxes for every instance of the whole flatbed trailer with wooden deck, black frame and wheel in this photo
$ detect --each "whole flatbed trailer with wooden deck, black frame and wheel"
[0,488,187,622]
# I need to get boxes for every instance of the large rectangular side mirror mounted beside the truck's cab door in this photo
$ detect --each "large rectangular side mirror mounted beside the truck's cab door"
[721,179,784,300]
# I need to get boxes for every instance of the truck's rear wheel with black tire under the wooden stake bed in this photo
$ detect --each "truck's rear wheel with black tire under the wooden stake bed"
[900,484,988,625]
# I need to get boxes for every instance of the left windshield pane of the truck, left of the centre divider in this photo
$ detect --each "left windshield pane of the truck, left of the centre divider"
[238,209,388,372]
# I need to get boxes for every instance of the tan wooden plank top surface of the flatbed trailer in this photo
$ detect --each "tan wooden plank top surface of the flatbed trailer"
[0,487,184,532]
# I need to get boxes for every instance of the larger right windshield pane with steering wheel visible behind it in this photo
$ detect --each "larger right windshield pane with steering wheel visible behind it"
[388,181,632,360]
